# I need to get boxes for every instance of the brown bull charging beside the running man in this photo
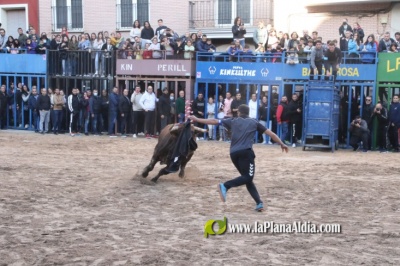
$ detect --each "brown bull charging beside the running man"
[141,123,207,183]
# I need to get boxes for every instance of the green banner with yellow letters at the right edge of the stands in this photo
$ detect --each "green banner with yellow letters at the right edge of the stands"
[377,53,400,82]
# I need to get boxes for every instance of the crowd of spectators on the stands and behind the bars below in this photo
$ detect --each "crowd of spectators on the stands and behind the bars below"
[0,17,400,150]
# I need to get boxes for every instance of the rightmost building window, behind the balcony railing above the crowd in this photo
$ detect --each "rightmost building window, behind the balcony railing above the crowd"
[216,0,253,25]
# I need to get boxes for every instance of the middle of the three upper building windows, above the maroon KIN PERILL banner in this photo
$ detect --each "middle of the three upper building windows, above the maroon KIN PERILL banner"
[117,0,149,30]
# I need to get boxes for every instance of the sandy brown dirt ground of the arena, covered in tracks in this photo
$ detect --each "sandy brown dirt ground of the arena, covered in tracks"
[0,131,400,265]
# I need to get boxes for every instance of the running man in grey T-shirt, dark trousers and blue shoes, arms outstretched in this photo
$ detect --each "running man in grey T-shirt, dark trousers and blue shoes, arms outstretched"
[189,104,289,211]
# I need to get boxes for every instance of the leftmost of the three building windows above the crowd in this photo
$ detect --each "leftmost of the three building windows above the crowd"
[52,0,83,31]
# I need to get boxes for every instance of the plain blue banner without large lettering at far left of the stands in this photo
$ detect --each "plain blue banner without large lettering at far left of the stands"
[0,54,47,74]
